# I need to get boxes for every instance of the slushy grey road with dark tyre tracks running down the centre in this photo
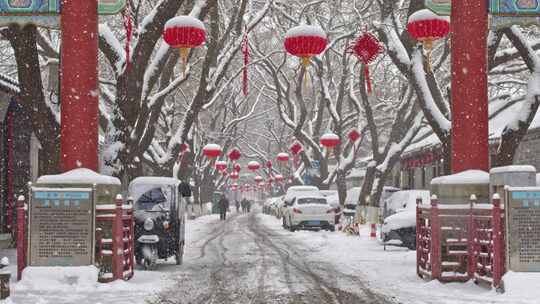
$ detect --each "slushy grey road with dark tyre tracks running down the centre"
[152,213,392,304]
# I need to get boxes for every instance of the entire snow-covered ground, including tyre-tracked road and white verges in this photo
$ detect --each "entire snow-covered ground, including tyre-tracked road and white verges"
[0,209,540,304]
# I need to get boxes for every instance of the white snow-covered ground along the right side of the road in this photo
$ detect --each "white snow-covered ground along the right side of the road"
[258,214,540,304]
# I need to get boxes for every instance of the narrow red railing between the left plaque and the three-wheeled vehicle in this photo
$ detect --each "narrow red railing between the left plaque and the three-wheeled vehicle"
[96,195,135,282]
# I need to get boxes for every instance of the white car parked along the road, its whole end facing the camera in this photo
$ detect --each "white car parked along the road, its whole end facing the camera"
[283,194,335,231]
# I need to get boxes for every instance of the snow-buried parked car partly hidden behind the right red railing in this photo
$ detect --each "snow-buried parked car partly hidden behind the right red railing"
[381,190,430,250]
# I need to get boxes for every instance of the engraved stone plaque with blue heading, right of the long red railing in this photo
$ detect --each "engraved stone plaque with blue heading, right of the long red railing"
[505,188,540,272]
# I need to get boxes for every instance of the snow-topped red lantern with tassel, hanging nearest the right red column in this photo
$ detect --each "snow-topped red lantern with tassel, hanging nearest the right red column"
[407,9,450,67]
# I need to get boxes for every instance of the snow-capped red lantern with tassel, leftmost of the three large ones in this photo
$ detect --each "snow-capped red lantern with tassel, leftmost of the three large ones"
[163,16,206,69]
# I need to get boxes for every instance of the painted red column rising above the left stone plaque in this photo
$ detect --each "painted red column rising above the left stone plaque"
[60,0,99,172]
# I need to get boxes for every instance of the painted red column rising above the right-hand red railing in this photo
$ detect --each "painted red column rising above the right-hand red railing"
[450,0,489,173]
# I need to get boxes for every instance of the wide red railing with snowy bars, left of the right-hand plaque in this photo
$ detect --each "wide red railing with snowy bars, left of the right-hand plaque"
[416,195,505,288]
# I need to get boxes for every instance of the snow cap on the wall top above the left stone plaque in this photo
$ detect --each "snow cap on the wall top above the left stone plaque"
[37,168,121,185]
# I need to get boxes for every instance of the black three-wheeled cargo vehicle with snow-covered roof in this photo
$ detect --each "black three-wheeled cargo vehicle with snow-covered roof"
[129,176,191,270]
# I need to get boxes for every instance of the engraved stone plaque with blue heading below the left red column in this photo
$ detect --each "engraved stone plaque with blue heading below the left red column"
[28,188,95,266]
